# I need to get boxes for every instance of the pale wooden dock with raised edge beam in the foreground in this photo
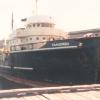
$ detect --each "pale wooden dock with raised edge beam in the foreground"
[0,84,100,100]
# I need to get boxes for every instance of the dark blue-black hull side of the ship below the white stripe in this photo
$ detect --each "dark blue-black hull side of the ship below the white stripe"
[1,38,100,84]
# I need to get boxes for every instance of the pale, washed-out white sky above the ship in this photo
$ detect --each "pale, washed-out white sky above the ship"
[0,0,100,39]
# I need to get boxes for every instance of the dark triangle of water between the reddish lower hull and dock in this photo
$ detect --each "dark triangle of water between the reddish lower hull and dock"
[0,76,29,90]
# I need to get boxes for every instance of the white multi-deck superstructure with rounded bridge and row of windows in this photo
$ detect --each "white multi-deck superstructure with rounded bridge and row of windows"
[9,15,68,51]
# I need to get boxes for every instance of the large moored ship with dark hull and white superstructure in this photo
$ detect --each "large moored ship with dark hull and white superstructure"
[0,0,100,84]
